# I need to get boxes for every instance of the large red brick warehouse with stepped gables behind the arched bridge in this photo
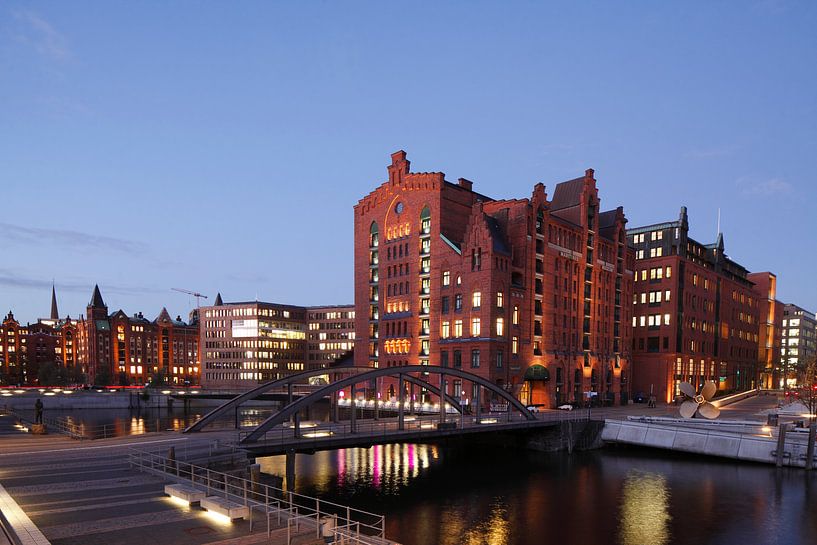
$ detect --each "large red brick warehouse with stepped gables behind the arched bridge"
[354,151,635,406]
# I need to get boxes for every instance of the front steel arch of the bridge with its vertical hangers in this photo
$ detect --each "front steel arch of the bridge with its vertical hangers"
[240,365,536,444]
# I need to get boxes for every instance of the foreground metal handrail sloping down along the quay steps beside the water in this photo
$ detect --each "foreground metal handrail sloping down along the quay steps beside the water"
[128,448,385,538]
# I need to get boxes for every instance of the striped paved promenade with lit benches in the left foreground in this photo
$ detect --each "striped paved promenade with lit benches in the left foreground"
[0,415,318,545]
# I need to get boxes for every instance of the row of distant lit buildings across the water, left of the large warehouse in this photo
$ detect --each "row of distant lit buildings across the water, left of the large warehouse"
[0,286,354,389]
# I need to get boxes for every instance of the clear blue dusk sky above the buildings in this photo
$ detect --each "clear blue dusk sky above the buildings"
[0,0,817,322]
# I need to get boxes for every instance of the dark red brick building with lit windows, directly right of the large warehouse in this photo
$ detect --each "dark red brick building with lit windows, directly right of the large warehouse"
[627,207,768,401]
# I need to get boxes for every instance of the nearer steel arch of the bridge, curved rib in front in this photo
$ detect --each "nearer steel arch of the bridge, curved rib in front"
[241,365,536,443]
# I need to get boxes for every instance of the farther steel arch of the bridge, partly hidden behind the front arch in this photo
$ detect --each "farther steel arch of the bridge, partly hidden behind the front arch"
[183,366,462,433]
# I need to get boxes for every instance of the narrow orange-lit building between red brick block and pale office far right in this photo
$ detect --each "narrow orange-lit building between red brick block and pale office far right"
[747,272,783,388]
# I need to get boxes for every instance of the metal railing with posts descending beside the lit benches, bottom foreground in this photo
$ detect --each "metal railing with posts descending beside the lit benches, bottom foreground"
[128,449,386,545]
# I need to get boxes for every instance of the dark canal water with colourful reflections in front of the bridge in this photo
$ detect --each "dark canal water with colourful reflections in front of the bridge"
[259,444,817,545]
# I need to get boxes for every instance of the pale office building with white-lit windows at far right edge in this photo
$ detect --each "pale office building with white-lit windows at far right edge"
[779,304,817,388]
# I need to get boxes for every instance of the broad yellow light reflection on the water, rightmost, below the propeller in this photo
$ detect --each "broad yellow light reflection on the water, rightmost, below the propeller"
[619,470,670,545]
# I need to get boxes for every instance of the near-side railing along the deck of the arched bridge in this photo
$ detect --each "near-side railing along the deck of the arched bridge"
[237,410,589,448]
